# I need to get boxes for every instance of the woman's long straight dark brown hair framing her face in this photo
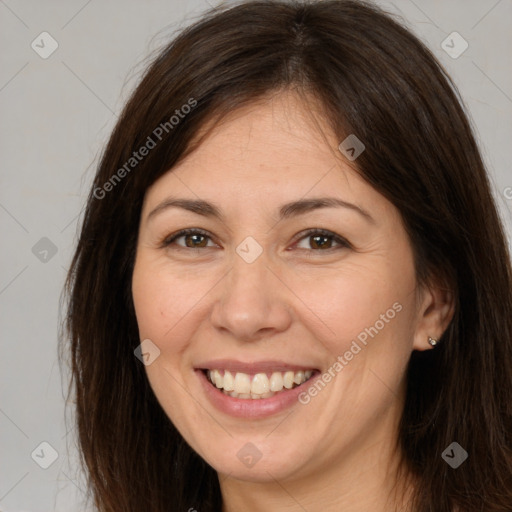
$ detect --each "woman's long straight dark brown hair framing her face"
[61,0,512,512]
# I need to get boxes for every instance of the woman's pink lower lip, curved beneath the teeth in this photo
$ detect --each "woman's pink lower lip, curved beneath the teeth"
[196,370,319,418]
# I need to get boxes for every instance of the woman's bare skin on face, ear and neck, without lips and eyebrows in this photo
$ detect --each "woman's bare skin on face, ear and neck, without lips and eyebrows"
[132,92,453,512]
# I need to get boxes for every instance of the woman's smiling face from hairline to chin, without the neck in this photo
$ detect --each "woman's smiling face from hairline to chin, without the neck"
[132,93,432,482]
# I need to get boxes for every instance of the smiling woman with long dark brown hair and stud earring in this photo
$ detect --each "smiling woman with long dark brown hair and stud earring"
[62,0,512,512]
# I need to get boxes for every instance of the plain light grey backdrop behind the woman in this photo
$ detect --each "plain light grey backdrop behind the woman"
[0,0,512,512]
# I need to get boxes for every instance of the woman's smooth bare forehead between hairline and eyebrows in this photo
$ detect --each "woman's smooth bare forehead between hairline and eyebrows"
[145,93,389,222]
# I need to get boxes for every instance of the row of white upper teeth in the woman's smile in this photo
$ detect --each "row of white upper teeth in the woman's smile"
[207,370,313,398]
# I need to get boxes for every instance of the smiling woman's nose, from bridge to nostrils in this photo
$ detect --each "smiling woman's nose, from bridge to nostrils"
[211,253,292,341]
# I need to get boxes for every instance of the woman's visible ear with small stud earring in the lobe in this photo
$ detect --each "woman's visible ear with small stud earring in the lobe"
[413,281,455,351]
